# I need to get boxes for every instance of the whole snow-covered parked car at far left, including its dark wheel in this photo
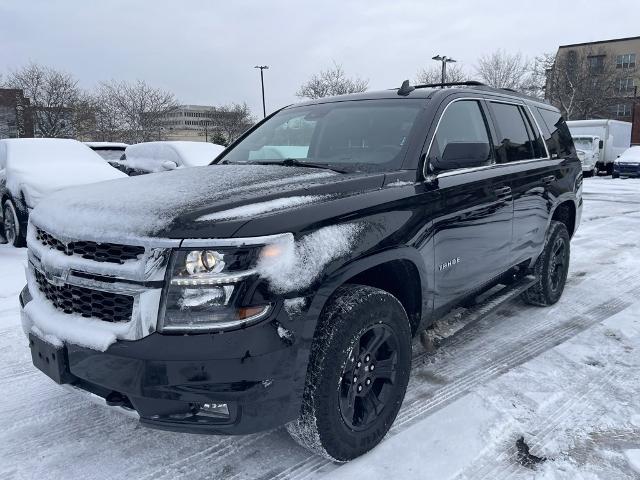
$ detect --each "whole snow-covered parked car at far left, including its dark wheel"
[0,138,126,247]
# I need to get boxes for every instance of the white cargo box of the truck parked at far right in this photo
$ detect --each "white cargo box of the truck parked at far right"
[567,119,631,175]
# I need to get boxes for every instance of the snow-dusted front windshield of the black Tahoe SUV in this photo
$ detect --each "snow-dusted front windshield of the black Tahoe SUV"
[222,100,424,171]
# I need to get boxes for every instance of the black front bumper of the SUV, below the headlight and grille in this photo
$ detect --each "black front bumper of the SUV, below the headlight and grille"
[21,291,310,434]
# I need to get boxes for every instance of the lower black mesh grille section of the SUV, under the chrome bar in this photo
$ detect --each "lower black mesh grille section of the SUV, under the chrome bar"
[34,270,133,323]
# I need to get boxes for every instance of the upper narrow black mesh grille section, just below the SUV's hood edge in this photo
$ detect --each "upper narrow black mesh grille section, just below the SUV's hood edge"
[35,228,144,265]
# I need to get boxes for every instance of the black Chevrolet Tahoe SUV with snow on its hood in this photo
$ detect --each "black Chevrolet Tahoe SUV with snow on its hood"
[21,82,582,461]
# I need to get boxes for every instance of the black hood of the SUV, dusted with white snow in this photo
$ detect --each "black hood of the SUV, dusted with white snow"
[31,165,384,243]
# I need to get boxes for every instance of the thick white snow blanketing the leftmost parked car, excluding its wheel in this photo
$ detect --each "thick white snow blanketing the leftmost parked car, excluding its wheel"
[0,138,126,207]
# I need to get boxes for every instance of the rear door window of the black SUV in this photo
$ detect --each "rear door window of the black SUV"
[490,102,546,162]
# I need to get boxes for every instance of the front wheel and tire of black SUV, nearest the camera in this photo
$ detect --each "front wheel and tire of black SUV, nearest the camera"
[287,285,411,462]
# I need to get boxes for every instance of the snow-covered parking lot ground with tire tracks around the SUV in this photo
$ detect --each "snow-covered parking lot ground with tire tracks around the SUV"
[0,177,640,480]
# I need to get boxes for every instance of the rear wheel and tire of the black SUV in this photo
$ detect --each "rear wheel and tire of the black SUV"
[521,220,571,307]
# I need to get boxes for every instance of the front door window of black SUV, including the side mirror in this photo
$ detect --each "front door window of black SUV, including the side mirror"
[428,100,492,171]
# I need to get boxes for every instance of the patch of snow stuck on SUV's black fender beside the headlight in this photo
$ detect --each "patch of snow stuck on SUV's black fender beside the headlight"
[256,224,361,293]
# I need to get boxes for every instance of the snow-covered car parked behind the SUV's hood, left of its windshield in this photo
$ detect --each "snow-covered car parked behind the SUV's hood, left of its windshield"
[111,141,225,175]
